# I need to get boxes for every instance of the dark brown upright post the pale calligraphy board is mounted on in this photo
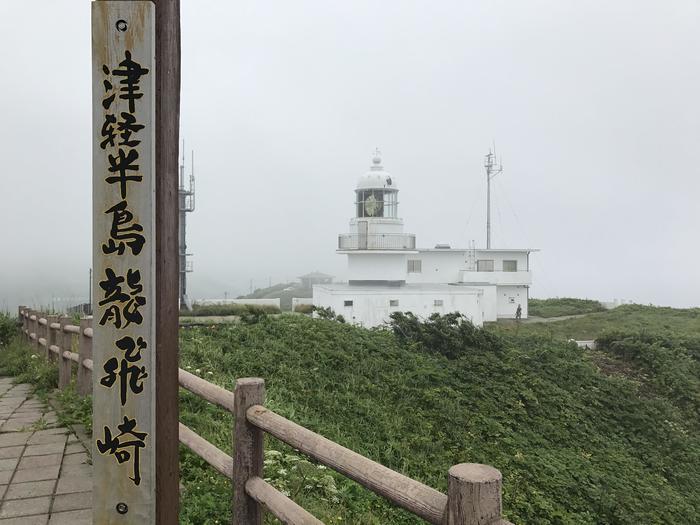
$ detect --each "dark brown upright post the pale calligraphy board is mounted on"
[155,0,180,525]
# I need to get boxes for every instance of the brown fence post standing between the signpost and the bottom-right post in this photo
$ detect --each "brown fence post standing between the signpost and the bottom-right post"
[232,377,265,525]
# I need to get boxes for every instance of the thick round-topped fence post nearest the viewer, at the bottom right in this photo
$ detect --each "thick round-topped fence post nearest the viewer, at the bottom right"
[447,463,502,525]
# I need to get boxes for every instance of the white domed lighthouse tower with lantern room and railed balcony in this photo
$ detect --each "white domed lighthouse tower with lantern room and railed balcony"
[338,150,417,286]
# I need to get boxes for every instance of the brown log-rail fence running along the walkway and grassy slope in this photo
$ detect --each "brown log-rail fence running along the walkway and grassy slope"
[19,306,512,525]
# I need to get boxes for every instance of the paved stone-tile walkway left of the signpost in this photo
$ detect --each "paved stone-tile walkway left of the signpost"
[0,377,92,525]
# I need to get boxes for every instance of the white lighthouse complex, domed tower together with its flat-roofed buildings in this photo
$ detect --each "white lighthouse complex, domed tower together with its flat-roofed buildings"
[313,149,536,327]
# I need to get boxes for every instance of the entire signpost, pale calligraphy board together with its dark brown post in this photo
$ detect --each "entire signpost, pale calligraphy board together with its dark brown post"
[92,0,180,525]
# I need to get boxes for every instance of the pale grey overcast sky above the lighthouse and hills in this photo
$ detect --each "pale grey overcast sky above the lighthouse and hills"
[0,0,700,309]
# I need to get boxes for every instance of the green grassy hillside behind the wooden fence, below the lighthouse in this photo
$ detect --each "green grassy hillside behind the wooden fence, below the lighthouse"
[182,307,700,525]
